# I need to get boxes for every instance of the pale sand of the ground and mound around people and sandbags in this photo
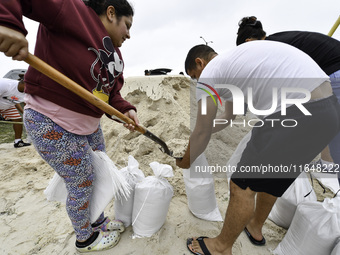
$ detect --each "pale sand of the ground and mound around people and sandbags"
[0,76,334,255]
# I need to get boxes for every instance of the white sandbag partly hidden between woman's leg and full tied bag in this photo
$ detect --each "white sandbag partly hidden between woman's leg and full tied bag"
[114,155,145,227]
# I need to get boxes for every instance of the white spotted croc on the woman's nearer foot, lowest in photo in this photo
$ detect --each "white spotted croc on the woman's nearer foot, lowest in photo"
[76,231,120,253]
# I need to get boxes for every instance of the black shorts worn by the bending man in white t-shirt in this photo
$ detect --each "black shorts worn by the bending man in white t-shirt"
[231,95,340,197]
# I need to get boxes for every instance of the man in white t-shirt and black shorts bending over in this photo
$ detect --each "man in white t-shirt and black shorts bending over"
[176,41,340,255]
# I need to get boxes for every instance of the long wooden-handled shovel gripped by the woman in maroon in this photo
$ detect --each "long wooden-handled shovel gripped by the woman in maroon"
[25,53,180,159]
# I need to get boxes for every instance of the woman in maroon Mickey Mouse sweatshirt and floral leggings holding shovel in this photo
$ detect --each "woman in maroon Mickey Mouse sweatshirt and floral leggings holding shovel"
[0,0,139,252]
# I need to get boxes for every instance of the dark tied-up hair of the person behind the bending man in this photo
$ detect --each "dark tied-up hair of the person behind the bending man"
[236,16,266,45]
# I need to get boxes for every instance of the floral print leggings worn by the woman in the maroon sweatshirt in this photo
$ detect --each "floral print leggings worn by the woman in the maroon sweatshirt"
[24,109,105,241]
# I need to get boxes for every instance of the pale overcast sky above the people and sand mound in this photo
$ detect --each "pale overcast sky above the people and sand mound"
[0,0,340,77]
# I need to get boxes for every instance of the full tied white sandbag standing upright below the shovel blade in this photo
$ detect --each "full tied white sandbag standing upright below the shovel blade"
[132,162,174,237]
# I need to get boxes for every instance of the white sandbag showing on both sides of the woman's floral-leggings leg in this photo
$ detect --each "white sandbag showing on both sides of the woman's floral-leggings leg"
[44,151,131,223]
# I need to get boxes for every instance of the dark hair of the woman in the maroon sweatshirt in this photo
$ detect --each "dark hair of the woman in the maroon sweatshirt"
[83,0,134,18]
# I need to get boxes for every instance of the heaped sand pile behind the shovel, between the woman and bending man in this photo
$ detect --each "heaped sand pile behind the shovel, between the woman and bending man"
[101,76,191,194]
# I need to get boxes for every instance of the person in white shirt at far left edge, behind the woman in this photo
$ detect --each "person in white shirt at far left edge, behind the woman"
[0,73,31,148]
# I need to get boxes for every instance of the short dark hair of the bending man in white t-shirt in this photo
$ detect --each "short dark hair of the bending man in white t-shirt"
[184,44,217,73]
